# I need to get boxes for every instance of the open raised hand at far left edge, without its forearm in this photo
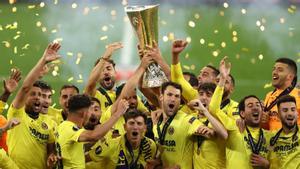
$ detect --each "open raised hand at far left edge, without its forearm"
[3,69,21,93]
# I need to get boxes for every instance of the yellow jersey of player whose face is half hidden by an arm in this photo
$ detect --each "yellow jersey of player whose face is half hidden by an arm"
[193,114,226,169]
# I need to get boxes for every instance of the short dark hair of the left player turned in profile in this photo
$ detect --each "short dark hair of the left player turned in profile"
[68,94,92,113]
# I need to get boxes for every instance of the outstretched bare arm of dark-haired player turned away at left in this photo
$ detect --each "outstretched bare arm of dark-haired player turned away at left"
[78,99,129,142]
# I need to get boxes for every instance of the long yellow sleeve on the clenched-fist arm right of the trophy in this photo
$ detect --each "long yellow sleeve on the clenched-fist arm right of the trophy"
[171,63,198,101]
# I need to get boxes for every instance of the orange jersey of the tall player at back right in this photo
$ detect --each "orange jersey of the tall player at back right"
[264,88,300,131]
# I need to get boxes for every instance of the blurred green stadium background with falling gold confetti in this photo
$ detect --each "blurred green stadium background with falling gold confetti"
[0,0,300,107]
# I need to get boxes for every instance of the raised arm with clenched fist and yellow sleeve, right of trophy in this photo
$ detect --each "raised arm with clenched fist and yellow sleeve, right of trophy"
[171,40,198,101]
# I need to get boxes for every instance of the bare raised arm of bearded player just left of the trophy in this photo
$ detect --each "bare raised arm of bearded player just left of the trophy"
[84,42,123,96]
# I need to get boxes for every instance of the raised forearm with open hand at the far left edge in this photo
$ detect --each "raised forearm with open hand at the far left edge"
[0,69,21,102]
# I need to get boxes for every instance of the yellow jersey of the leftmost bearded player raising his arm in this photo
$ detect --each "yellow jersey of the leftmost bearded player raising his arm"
[7,105,56,169]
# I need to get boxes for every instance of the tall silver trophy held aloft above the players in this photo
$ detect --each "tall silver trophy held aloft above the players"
[125,5,168,88]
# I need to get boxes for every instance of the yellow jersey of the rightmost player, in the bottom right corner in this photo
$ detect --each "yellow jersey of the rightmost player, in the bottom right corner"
[270,127,300,169]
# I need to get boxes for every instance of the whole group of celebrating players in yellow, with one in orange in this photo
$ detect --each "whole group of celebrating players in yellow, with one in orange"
[0,40,300,169]
